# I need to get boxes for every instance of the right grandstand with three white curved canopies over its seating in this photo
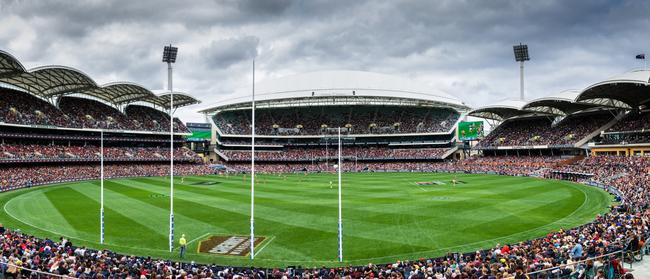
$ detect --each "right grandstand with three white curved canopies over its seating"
[468,70,650,159]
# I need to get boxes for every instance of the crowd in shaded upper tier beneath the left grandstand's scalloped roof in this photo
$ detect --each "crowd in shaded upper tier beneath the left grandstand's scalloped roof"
[0,89,189,133]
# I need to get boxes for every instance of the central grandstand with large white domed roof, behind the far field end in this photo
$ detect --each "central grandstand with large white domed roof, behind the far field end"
[201,71,469,166]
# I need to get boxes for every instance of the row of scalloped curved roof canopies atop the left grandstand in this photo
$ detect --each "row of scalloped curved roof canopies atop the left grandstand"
[0,51,200,108]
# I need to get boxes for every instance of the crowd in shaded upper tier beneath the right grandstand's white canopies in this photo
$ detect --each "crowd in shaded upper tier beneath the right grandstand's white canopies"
[479,113,614,147]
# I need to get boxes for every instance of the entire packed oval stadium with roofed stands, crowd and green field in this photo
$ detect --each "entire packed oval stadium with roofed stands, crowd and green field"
[0,42,650,278]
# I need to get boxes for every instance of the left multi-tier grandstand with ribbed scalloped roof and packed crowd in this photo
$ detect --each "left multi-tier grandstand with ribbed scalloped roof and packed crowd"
[0,51,208,191]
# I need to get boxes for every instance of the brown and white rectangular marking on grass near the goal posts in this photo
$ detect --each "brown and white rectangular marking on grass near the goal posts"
[198,235,266,256]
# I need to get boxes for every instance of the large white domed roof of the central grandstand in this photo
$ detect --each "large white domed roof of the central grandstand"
[200,71,468,113]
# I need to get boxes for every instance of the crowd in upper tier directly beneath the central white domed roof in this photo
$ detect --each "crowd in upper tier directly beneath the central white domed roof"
[214,106,460,135]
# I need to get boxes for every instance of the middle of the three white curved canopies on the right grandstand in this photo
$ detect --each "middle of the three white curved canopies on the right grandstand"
[522,90,595,116]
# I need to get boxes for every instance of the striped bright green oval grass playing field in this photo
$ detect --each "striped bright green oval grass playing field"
[0,173,611,267]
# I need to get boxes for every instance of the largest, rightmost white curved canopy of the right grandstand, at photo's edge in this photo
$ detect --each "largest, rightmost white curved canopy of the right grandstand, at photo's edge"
[576,70,650,109]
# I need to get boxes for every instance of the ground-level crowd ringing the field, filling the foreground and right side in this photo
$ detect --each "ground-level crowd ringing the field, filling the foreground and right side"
[0,156,650,279]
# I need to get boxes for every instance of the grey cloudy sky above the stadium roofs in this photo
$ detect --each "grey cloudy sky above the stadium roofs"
[0,0,650,121]
